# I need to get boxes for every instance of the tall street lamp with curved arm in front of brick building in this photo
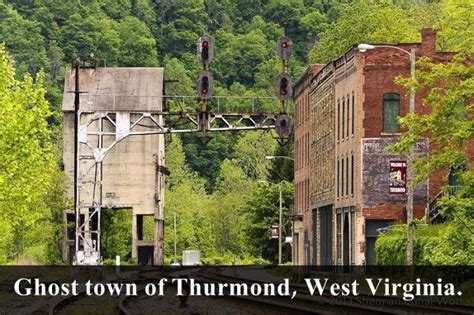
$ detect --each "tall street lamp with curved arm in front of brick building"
[357,44,415,265]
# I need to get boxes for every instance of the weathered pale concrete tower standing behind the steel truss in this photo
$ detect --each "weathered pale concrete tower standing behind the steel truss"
[63,68,165,264]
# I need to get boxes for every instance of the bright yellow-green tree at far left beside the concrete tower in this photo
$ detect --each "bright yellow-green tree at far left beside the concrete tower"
[0,45,64,263]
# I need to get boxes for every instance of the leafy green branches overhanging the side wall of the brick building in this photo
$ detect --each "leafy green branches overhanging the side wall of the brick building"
[391,56,474,186]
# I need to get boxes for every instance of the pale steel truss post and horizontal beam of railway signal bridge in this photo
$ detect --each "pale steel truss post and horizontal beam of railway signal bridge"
[74,111,286,265]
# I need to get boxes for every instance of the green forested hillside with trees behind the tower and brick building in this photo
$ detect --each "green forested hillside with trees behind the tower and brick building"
[0,0,474,263]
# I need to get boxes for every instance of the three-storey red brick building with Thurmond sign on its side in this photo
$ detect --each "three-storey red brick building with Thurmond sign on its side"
[293,29,451,265]
